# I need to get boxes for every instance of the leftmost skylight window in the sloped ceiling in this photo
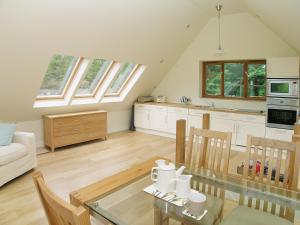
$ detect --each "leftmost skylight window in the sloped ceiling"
[38,55,78,98]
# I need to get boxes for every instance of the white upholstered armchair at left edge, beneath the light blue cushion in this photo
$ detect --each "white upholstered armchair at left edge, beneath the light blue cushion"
[0,132,37,187]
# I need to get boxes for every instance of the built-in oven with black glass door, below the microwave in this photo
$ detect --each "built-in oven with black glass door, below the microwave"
[267,98,299,130]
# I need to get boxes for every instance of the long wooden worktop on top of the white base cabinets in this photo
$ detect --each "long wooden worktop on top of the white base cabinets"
[136,102,265,116]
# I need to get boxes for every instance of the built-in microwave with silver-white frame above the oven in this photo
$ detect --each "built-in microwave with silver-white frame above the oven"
[267,78,300,98]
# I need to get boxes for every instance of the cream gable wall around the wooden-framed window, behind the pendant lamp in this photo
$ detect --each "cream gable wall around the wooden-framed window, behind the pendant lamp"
[153,13,298,109]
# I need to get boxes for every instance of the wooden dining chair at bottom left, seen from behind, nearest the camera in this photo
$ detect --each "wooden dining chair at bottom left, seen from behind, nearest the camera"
[33,172,91,225]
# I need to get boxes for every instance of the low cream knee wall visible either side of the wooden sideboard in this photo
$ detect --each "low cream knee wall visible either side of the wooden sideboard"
[16,110,131,147]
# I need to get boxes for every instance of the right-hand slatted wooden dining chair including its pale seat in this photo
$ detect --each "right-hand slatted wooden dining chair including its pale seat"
[222,136,300,225]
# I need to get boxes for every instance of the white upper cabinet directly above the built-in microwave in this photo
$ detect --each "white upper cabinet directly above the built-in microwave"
[267,57,299,78]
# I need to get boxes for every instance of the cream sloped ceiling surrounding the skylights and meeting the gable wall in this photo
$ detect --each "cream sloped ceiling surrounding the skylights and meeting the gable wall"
[0,0,300,121]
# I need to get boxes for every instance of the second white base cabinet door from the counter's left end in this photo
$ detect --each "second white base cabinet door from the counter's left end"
[149,106,168,132]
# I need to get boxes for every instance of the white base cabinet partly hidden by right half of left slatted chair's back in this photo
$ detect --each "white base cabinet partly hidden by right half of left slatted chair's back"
[210,117,236,145]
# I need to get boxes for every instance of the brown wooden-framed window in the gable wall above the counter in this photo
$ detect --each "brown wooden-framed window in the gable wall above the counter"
[202,60,266,100]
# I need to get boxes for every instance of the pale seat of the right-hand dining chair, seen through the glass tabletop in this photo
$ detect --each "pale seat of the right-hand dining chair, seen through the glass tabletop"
[220,206,293,225]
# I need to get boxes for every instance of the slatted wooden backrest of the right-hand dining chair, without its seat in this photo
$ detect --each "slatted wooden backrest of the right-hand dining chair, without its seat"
[239,136,300,222]
